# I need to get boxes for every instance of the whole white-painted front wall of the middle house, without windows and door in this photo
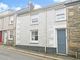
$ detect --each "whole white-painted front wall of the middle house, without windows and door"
[16,6,66,48]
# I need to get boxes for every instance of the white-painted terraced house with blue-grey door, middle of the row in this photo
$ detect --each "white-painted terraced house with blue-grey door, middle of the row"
[16,3,68,55]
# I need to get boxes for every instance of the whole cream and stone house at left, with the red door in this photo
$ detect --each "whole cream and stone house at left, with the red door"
[0,10,15,45]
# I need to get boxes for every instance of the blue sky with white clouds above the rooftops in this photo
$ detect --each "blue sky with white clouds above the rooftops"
[0,0,65,12]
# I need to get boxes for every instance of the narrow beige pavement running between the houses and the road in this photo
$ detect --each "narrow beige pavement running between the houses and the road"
[1,46,80,60]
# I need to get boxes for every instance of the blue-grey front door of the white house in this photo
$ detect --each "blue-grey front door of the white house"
[57,29,66,54]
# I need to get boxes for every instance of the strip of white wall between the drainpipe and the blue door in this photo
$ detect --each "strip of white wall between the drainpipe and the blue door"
[47,9,56,47]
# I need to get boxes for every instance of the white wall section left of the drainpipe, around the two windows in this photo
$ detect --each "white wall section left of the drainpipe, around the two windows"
[16,12,46,47]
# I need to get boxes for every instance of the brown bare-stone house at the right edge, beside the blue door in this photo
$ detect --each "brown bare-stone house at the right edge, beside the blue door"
[65,0,80,58]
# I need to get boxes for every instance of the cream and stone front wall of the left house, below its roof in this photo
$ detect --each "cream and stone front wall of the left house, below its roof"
[0,14,16,45]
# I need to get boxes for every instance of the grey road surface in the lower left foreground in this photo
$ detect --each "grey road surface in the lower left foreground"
[0,48,51,60]
